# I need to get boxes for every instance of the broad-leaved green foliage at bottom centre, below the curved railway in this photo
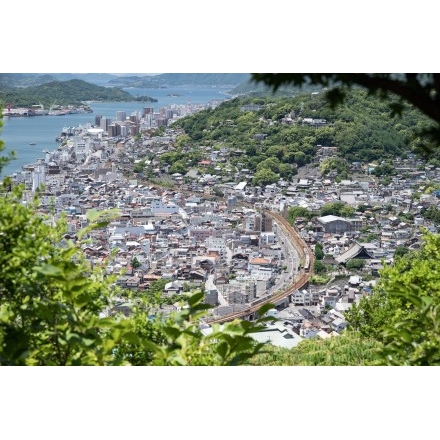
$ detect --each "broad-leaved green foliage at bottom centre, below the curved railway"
[114,292,267,366]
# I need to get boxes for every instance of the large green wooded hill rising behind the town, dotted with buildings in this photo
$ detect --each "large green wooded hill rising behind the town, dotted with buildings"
[173,90,429,165]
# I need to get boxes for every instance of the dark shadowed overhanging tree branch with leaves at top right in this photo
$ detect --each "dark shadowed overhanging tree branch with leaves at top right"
[252,73,440,156]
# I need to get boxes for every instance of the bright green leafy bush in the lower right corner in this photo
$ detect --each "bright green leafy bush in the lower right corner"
[345,233,440,365]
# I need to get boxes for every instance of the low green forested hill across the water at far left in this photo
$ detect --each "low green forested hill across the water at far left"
[0,79,156,107]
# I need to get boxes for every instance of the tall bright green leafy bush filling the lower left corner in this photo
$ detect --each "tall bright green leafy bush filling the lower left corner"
[0,188,127,365]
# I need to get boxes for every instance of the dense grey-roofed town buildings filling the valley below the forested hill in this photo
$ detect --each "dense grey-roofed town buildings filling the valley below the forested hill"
[3,100,440,347]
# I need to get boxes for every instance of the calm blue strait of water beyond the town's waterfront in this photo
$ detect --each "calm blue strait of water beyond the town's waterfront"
[0,87,230,177]
